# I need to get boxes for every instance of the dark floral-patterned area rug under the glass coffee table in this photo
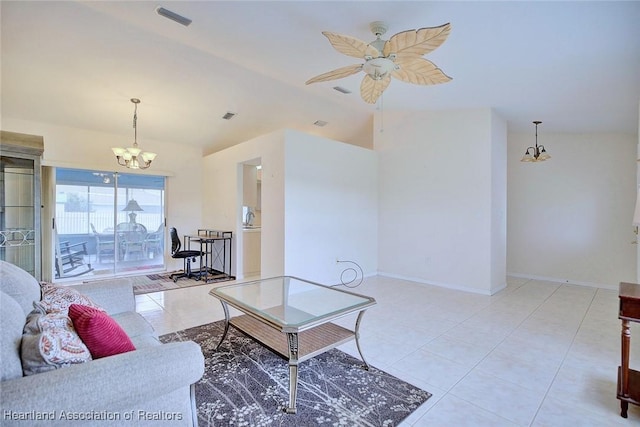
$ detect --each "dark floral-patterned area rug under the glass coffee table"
[160,321,431,427]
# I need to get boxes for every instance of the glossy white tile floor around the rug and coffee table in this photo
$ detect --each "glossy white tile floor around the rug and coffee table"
[136,276,640,427]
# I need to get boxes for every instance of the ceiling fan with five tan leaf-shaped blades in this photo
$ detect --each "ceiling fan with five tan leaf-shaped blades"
[306,21,451,104]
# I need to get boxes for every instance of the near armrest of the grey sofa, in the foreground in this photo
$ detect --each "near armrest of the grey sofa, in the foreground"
[0,341,204,413]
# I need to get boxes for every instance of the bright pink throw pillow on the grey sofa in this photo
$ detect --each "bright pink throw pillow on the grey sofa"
[69,304,136,359]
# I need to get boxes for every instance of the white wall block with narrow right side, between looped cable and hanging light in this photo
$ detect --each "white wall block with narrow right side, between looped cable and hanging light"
[374,109,506,294]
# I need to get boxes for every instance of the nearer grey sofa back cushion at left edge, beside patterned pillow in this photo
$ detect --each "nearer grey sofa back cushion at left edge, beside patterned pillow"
[0,290,25,387]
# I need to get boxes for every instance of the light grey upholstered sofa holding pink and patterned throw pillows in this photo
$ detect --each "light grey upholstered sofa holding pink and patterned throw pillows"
[0,261,204,426]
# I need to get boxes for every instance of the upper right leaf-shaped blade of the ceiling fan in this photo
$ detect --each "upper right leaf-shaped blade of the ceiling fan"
[382,23,451,57]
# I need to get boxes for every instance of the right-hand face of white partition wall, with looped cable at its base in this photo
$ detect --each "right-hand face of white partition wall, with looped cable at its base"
[282,131,378,284]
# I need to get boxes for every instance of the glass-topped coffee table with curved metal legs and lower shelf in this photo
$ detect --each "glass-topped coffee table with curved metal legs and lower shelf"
[209,276,376,414]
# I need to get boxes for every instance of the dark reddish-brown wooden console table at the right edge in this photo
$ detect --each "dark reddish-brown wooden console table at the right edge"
[618,282,640,418]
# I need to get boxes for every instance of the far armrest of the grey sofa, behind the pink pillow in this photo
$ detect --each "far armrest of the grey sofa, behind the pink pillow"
[72,278,136,314]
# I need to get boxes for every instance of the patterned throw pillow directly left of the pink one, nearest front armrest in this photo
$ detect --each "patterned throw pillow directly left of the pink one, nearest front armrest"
[21,304,91,375]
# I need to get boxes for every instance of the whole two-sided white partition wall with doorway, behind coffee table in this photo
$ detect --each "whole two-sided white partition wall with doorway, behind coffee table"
[203,129,377,284]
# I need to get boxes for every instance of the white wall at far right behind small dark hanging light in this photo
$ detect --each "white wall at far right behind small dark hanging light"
[507,132,638,289]
